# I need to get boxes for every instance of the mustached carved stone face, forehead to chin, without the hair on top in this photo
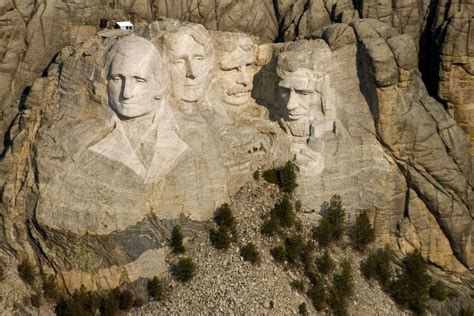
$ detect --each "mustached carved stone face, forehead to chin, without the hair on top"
[217,48,256,106]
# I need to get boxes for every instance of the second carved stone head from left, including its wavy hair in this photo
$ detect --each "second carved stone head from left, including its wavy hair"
[165,25,214,102]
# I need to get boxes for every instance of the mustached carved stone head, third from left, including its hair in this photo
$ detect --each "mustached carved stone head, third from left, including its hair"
[216,34,256,106]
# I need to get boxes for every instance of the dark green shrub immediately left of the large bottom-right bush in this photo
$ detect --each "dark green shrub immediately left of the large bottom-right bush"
[360,245,393,289]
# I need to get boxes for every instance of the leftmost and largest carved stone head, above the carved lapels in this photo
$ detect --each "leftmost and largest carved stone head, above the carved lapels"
[107,35,168,119]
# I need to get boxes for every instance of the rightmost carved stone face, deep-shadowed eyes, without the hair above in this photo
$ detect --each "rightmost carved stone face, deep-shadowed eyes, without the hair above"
[278,68,318,123]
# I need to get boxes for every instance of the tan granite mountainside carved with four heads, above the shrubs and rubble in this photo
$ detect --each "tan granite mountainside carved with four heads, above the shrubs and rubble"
[0,15,474,316]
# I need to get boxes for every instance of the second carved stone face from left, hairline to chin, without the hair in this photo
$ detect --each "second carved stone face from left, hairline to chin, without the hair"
[167,33,212,102]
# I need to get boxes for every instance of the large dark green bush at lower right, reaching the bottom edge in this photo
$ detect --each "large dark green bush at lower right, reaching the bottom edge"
[391,251,431,313]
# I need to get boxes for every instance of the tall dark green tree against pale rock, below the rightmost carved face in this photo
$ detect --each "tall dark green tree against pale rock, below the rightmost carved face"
[313,195,345,247]
